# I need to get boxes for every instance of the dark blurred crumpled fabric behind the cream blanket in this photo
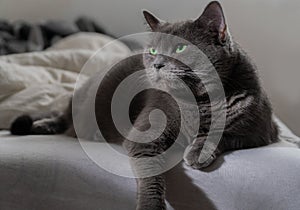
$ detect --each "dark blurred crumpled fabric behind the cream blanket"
[0,17,111,55]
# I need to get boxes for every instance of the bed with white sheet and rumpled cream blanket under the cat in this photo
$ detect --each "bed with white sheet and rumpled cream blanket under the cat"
[0,34,300,210]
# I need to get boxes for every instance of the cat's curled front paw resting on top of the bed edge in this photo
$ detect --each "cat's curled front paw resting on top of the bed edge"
[183,144,217,169]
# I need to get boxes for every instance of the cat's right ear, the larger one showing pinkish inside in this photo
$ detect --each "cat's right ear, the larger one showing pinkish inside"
[195,1,230,44]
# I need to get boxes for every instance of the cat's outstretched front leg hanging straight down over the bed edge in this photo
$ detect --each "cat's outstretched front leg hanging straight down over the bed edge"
[123,94,180,210]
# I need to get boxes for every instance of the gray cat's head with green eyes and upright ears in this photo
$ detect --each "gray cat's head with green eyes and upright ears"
[143,2,234,93]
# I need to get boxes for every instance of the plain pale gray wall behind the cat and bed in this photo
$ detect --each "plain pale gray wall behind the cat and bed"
[0,0,300,135]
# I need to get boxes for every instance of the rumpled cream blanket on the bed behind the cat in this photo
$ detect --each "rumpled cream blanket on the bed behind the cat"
[0,33,130,129]
